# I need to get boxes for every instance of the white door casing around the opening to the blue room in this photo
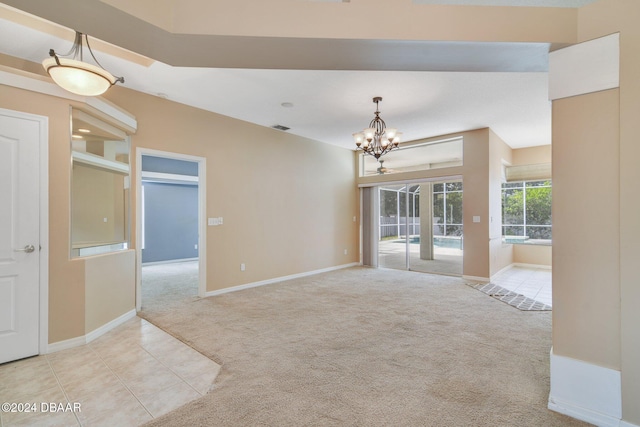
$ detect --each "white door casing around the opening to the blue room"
[135,147,207,311]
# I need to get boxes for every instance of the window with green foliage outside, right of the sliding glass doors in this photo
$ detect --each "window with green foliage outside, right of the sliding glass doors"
[502,180,551,245]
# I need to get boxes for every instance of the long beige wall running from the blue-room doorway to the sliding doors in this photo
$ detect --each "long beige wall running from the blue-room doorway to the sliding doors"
[102,88,359,291]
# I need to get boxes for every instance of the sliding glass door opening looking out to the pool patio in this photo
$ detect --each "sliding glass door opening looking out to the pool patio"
[376,180,464,275]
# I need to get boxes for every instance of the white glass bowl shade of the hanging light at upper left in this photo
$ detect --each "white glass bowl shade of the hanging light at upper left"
[42,58,116,96]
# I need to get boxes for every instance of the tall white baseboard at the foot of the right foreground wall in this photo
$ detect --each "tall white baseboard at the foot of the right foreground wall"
[548,349,622,427]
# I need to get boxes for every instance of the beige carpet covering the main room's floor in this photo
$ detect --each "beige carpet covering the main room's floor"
[142,268,585,426]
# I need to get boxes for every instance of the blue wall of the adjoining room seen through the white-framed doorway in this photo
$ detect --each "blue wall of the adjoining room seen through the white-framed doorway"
[142,181,198,263]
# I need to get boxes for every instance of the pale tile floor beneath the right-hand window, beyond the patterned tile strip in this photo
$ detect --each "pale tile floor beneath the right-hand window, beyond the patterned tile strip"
[491,267,552,305]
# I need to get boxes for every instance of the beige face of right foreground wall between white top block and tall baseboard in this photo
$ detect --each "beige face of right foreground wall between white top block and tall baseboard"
[553,89,620,369]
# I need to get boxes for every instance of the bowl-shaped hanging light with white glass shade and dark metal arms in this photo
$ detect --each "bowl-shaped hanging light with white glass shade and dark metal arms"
[42,31,124,96]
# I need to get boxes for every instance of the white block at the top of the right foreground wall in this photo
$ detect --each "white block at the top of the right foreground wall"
[549,33,620,101]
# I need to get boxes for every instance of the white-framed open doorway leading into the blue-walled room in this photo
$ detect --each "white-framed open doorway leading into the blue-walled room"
[136,148,206,311]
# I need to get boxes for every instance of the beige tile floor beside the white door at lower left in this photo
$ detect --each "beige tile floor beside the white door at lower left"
[0,317,220,427]
